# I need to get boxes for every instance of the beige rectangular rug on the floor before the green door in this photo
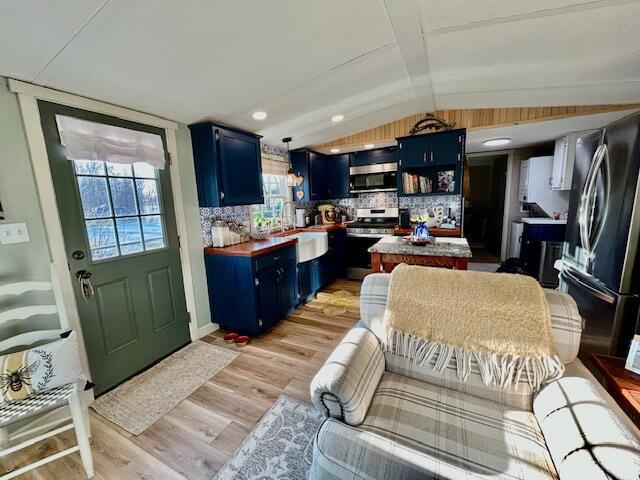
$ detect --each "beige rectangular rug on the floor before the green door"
[91,340,239,435]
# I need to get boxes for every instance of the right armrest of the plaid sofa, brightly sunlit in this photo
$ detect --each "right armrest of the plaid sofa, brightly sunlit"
[533,360,640,480]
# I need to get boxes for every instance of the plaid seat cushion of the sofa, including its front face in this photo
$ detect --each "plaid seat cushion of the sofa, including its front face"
[312,373,557,480]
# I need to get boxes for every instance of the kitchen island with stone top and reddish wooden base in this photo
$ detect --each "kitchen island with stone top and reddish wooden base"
[368,236,472,273]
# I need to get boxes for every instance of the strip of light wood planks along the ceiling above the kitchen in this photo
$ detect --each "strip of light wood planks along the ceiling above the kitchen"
[315,103,640,149]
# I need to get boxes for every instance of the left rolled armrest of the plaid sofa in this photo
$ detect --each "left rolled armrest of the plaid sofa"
[311,326,384,425]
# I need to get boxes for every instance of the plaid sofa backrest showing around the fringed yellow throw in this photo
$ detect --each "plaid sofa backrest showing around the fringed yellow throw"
[360,273,582,410]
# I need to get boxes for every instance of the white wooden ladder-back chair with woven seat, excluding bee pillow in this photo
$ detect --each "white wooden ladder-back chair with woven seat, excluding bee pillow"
[0,268,93,480]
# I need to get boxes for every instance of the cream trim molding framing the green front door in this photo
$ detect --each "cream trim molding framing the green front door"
[9,79,202,382]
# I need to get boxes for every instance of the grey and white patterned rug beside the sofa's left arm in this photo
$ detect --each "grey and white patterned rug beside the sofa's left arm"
[213,395,324,480]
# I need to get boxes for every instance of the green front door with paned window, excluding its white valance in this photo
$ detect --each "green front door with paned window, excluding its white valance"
[39,101,190,393]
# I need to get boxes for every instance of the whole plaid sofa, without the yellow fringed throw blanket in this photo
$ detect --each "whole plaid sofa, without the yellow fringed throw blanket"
[310,274,640,480]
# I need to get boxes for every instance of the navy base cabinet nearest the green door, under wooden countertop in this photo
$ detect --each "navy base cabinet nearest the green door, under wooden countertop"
[205,246,298,335]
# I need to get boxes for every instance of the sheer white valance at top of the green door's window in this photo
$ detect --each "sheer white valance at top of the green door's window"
[56,115,165,170]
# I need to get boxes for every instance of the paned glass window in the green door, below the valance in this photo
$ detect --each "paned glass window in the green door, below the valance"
[73,160,167,261]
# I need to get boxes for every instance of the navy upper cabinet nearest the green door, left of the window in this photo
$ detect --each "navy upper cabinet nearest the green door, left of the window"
[189,122,264,207]
